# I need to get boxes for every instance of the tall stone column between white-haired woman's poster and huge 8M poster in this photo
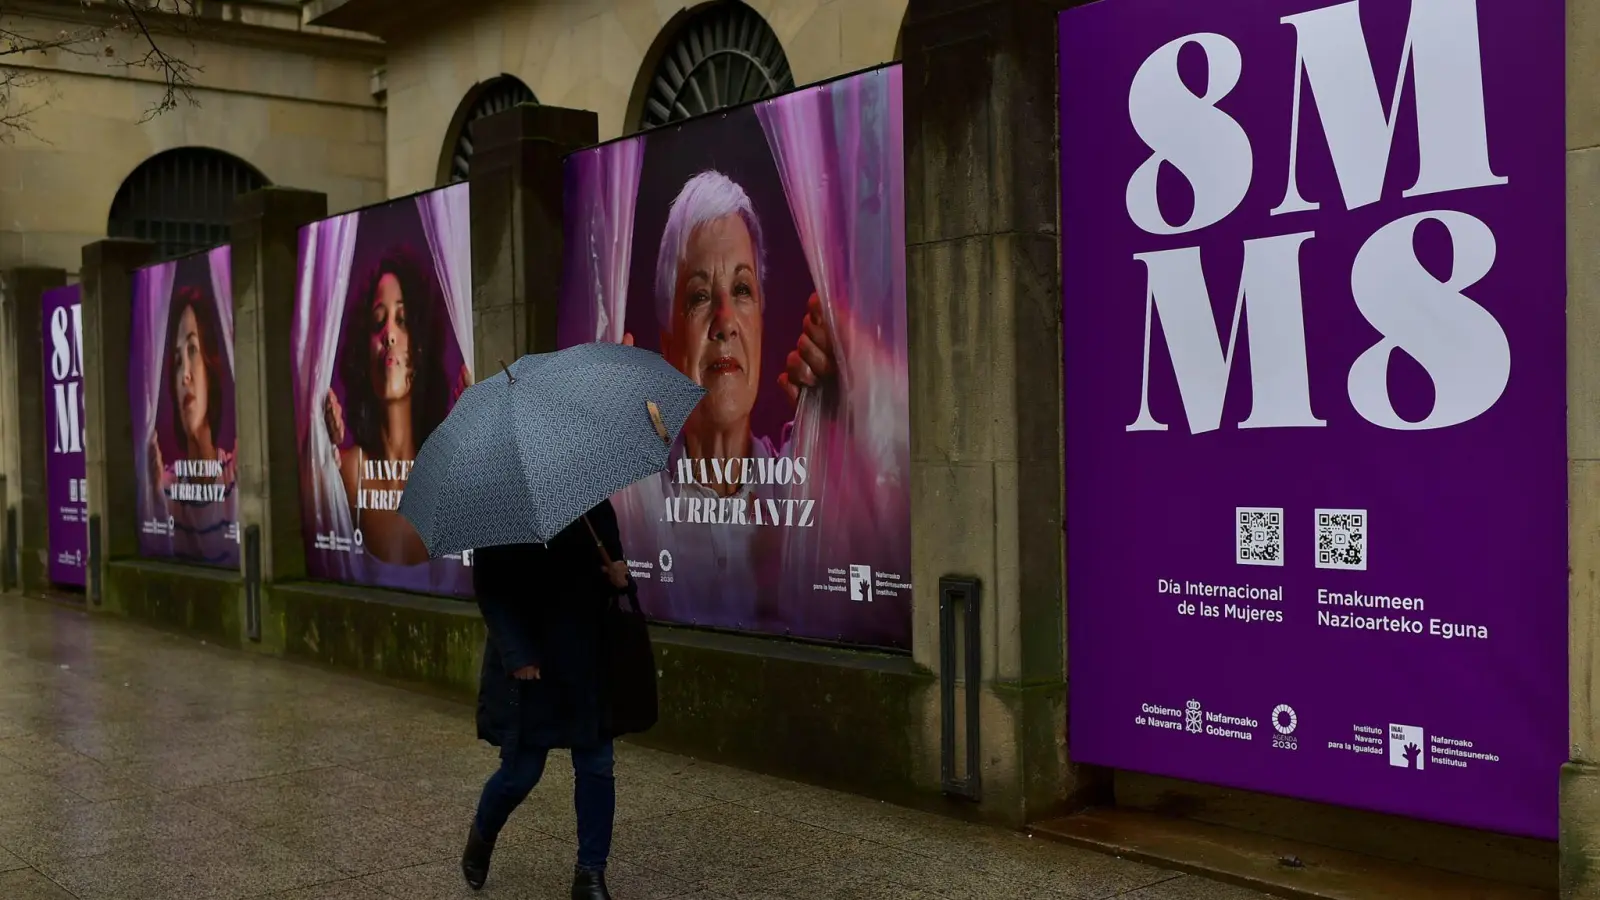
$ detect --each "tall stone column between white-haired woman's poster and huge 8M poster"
[901,0,1078,823]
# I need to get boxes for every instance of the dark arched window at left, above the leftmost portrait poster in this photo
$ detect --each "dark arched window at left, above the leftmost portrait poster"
[106,147,267,259]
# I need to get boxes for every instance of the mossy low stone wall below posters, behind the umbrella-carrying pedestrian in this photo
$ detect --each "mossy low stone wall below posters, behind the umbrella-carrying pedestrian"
[262,581,941,806]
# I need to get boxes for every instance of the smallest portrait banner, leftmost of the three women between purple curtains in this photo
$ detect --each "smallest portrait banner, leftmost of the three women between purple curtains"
[128,247,238,567]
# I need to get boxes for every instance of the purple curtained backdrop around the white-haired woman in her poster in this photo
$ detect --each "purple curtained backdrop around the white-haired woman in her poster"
[557,67,914,650]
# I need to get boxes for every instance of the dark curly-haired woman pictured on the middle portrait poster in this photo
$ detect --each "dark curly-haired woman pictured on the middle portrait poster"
[323,247,470,565]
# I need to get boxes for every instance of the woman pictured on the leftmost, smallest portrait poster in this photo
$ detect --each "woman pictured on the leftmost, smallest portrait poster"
[149,280,234,559]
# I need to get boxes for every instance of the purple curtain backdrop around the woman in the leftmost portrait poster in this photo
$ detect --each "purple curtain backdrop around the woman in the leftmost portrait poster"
[128,247,240,569]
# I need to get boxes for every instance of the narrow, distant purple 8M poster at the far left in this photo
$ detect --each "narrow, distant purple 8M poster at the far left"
[40,285,90,588]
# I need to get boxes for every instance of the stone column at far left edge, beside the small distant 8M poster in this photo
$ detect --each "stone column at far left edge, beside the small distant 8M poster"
[0,269,67,591]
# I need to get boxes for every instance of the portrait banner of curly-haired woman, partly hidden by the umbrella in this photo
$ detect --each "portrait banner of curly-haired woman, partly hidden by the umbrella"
[291,184,472,596]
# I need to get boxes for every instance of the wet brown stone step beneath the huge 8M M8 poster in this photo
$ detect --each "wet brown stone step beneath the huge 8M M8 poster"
[1034,809,1557,900]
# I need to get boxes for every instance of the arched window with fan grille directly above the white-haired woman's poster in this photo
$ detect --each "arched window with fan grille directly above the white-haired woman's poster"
[638,0,795,130]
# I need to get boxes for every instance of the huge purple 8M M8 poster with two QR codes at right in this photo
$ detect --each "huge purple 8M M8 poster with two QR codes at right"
[1061,0,1566,838]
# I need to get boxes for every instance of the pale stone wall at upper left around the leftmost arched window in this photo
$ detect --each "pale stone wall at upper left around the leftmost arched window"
[0,0,386,274]
